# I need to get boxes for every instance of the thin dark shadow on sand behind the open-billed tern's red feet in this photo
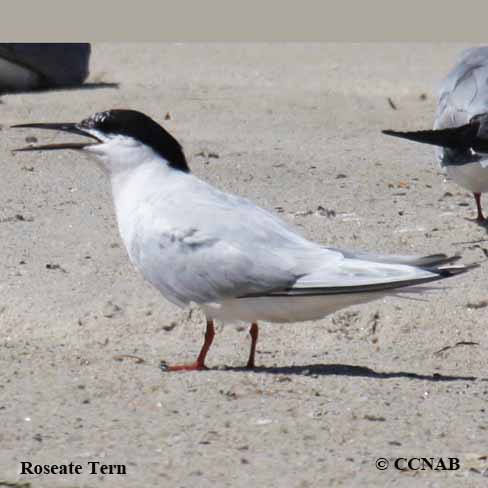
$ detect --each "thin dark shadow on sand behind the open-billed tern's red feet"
[223,364,480,382]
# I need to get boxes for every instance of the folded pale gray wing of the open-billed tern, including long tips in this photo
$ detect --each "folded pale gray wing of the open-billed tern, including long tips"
[131,174,466,305]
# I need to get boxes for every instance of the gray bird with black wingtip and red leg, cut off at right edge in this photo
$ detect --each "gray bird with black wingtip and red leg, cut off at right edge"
[383,46,488,224]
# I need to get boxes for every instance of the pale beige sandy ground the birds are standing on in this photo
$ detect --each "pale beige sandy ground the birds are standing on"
[0,44,488,488]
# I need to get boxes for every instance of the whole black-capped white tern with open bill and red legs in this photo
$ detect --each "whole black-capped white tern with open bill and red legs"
[14,110,470,371]
